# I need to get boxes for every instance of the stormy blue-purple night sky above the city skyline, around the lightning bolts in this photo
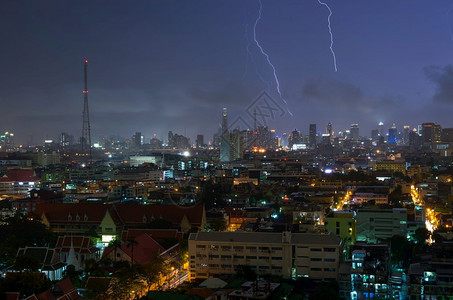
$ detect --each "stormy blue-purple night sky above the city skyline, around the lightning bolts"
[0,0,453,143]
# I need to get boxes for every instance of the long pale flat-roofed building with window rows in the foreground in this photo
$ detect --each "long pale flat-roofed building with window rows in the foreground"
[189,232,342,280]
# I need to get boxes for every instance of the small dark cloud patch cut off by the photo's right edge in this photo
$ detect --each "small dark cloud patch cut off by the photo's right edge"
[424,65,453,103]
